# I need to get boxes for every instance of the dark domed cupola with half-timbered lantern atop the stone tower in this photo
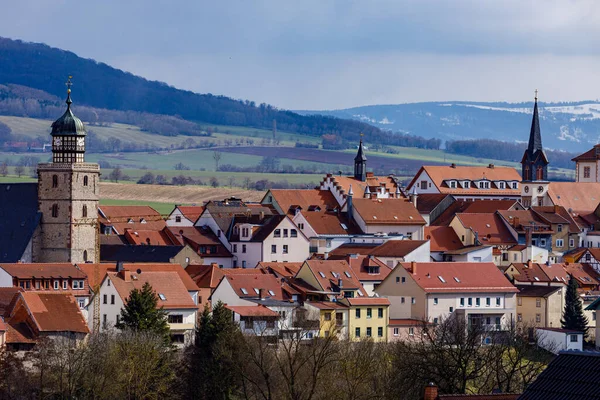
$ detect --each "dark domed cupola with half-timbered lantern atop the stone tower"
[51,76,86,164]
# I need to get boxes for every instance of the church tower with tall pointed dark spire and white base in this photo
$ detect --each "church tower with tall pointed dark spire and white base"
[521,90,549,207]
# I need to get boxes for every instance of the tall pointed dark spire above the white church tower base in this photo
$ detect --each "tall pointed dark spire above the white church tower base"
[521,90,549,182]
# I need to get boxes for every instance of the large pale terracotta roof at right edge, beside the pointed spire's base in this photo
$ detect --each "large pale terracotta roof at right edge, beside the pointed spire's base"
[548,182,600,213]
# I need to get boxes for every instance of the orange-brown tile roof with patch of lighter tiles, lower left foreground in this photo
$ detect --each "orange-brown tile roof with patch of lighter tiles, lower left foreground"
[20,291,89,333]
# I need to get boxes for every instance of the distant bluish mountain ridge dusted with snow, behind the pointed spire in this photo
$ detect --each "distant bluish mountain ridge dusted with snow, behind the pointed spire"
[297,101,600,152]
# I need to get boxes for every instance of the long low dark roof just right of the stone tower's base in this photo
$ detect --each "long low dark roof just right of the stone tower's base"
[100,244,183,263]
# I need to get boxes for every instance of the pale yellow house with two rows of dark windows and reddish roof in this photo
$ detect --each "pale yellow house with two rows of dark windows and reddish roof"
[340,297,390,342]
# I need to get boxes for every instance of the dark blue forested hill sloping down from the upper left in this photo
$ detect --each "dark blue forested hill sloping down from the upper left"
[0,37,432,146]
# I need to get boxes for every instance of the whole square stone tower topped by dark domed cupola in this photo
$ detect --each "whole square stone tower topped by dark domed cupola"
[34,77,100,263]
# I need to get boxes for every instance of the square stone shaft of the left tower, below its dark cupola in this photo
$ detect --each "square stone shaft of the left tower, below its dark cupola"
[33,163,100,263]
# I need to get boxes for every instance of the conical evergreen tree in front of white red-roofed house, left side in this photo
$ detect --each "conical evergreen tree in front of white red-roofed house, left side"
[116,282,171,343]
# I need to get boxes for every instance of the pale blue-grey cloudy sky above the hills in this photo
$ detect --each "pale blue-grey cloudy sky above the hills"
[0,0,600,109]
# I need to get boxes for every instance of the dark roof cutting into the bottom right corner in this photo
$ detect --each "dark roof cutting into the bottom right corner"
[519,351,600,400]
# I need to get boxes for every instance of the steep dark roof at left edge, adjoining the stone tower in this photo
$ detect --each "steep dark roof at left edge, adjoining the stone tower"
[0,183,42,263]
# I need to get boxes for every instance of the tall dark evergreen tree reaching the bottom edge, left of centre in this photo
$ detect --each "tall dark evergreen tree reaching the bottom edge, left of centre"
[182,302,243,399]
